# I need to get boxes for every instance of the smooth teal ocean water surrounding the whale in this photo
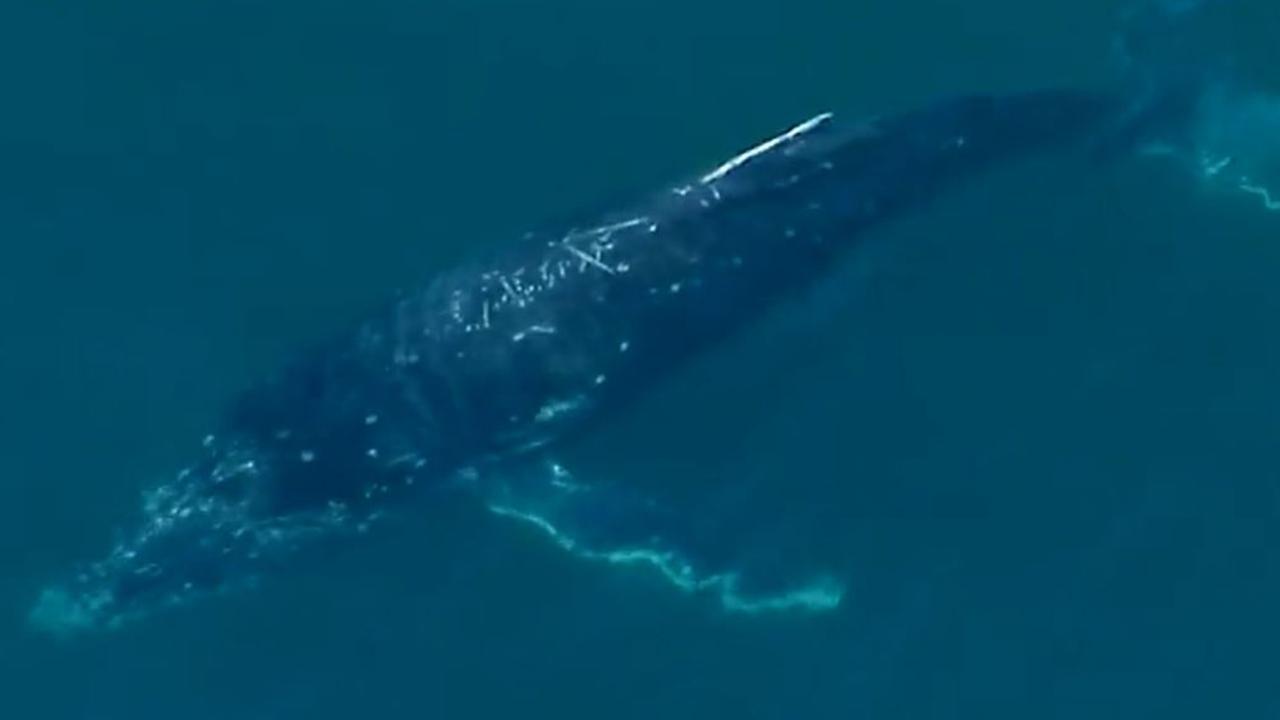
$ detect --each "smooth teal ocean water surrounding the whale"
[0,0,1280,720]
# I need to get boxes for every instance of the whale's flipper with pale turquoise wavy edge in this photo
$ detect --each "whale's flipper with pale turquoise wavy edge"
[479,461,844,614]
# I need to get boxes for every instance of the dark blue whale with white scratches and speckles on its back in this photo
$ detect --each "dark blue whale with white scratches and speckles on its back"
[32,91,1115,630]
